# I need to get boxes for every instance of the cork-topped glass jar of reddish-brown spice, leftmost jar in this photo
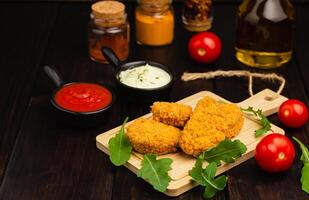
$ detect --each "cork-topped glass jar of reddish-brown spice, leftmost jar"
[88,1,130,63]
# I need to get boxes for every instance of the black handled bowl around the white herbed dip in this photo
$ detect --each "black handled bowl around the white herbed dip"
[102,47,174,103]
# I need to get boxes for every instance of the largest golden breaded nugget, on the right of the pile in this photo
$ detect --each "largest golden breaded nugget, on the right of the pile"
[179,96,244,156]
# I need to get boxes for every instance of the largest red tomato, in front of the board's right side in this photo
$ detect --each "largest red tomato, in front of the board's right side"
[255,133,295,172]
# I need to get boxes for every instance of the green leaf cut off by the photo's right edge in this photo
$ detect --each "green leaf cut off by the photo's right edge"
[293,137,309,194]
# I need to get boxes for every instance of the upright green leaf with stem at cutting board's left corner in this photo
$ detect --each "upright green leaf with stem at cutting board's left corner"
[108,117,132,166]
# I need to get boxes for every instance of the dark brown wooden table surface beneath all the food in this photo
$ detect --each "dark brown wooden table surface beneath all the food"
[0,1,309,200]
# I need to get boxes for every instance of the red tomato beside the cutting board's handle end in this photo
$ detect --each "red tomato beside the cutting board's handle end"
[278,99,308,128]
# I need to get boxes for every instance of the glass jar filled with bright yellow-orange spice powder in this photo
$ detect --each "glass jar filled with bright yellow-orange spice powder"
[135,0,174,46]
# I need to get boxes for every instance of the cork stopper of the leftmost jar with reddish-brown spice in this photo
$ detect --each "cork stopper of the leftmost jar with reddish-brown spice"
[91,1,127,27]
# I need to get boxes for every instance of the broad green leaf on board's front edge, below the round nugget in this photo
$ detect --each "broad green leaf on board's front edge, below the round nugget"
[137,154,173,192]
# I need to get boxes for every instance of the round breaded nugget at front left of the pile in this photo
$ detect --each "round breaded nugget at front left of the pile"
[126,118,181,155]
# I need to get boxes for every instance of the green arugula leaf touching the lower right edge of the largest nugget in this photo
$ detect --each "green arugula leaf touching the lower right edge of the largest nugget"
[202,139,247,165]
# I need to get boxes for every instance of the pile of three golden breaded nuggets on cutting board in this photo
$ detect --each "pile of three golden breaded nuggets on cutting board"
[126,96,244,156]
